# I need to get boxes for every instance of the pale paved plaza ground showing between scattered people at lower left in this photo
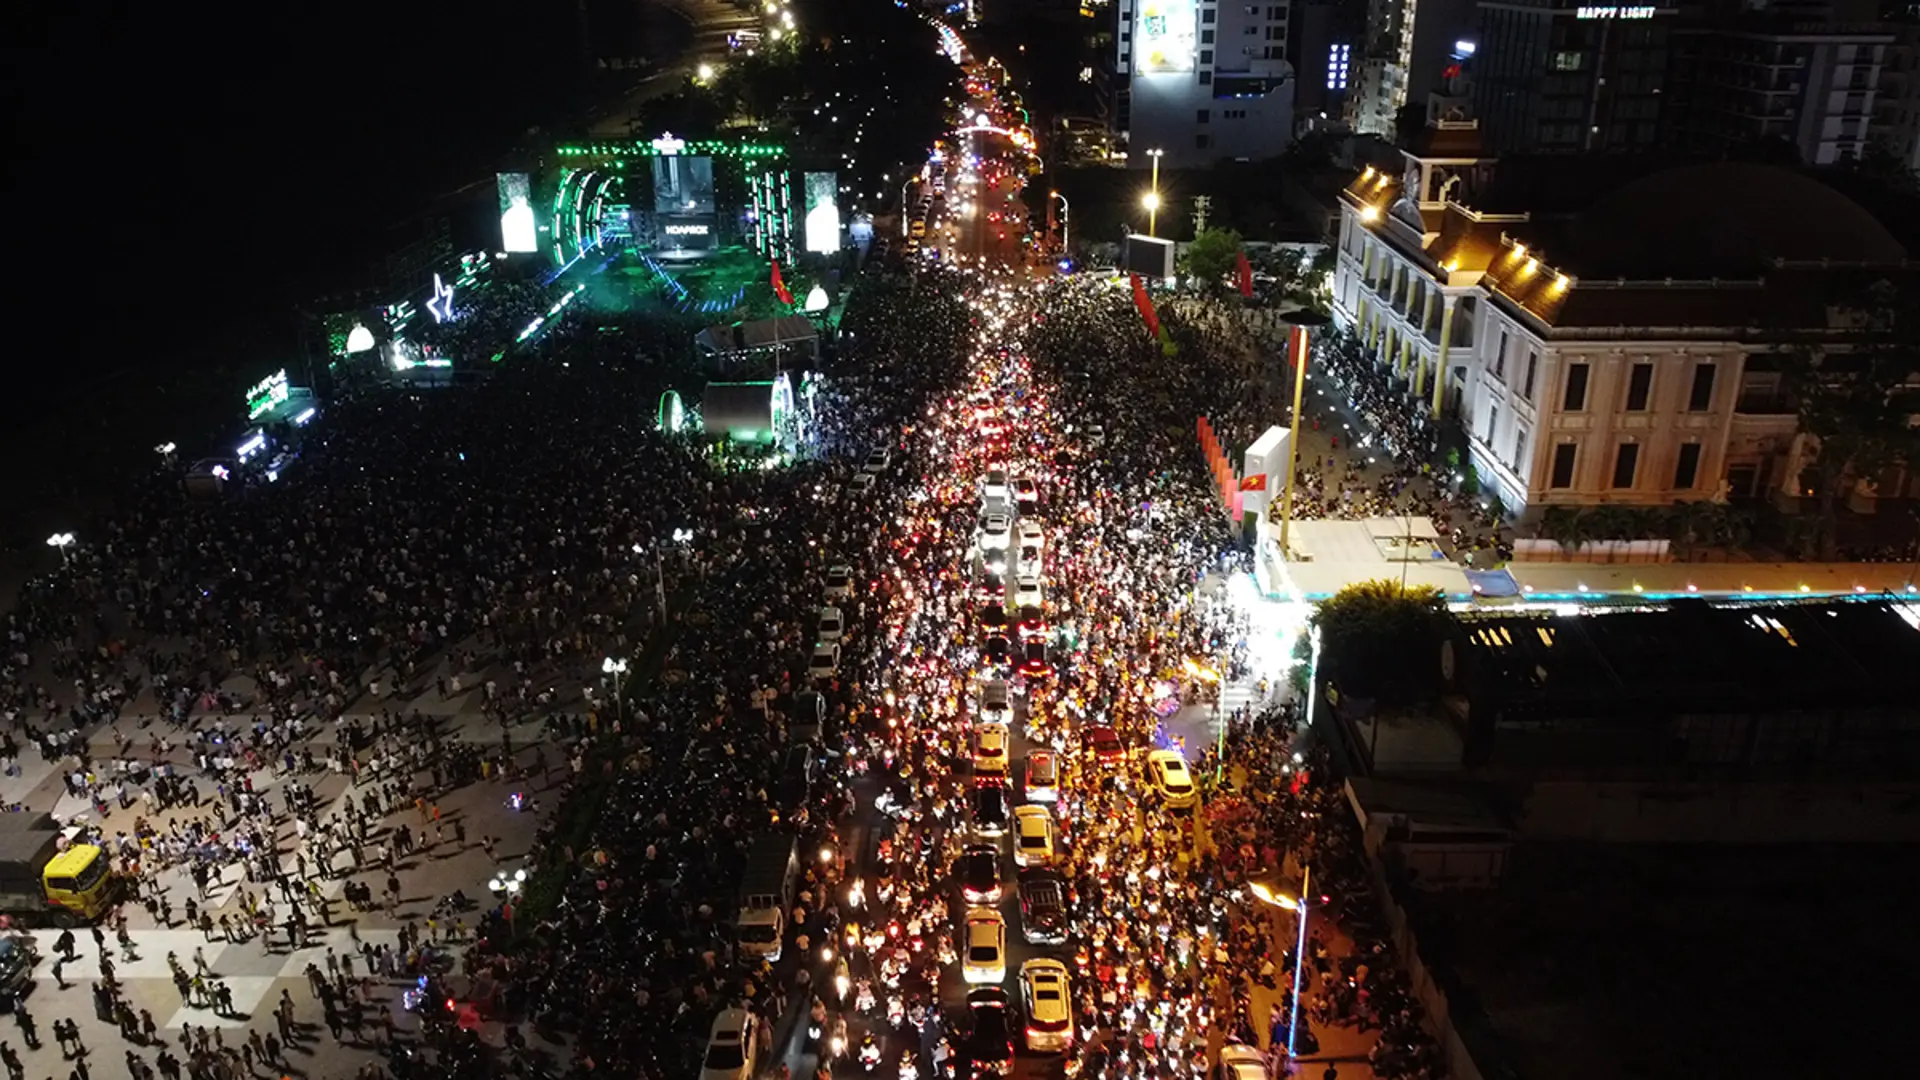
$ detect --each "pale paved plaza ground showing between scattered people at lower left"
[0,664,566,1078]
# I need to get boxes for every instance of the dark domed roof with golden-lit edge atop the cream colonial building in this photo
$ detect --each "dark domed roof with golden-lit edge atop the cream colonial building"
[1344,148,1907,329]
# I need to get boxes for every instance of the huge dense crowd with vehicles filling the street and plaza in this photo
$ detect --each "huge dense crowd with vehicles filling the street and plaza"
[0,50,1438,1080]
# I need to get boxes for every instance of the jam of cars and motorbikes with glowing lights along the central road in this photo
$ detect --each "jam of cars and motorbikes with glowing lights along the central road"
[821,263,1215,1080]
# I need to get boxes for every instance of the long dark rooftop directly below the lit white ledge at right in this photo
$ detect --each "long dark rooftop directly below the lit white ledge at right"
[1455,600,1920,719]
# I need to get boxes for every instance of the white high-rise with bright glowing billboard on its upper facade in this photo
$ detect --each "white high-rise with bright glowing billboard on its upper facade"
[1112,0,1296,167]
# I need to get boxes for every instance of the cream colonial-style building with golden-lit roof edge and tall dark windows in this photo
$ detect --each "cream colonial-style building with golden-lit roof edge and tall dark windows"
[1334,111,1920,519]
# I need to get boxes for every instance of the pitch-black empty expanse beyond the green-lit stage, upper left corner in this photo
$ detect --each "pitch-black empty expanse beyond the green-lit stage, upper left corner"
[0,0,578,419]
